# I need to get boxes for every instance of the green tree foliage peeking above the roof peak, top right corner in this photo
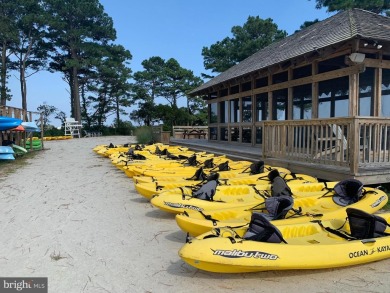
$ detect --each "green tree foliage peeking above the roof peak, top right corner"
[309,0,390,15]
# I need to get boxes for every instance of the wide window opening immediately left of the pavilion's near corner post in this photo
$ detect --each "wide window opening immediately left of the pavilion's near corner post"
[318,76,349,118]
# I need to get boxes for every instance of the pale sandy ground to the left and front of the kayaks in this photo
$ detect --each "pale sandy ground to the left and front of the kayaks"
[0,136,390,293]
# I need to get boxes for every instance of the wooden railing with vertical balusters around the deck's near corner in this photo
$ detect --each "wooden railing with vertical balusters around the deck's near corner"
[262,117,390,174]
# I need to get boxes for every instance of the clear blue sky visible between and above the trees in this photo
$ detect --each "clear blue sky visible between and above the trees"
[7,0,333,126]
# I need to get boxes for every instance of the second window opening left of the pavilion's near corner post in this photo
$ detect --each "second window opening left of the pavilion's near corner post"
[293,84,312,119]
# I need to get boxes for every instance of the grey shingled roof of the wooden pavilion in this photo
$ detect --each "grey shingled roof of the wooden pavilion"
[190,9,390,95]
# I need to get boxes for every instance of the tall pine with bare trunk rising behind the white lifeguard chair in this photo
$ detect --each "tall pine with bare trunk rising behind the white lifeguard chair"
[44,0,116,121]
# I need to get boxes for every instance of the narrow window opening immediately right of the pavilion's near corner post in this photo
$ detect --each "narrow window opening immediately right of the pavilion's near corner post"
[358,67,375,116]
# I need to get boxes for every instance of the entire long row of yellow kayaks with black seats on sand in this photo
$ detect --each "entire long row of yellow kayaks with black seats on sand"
[94,144,390,273]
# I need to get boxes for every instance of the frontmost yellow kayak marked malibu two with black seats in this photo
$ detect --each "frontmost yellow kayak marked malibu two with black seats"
[179,209,390,273]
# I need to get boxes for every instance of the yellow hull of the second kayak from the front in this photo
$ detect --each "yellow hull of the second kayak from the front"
[175,183,388,236]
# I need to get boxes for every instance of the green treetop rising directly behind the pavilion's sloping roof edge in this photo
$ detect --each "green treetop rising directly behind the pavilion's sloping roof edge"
[202,16,287,72]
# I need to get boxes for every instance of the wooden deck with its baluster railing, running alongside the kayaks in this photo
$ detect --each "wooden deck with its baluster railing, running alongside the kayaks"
[170,117,390,184]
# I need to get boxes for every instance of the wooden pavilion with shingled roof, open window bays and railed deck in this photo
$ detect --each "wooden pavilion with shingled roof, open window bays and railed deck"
[190,9,390,184]
